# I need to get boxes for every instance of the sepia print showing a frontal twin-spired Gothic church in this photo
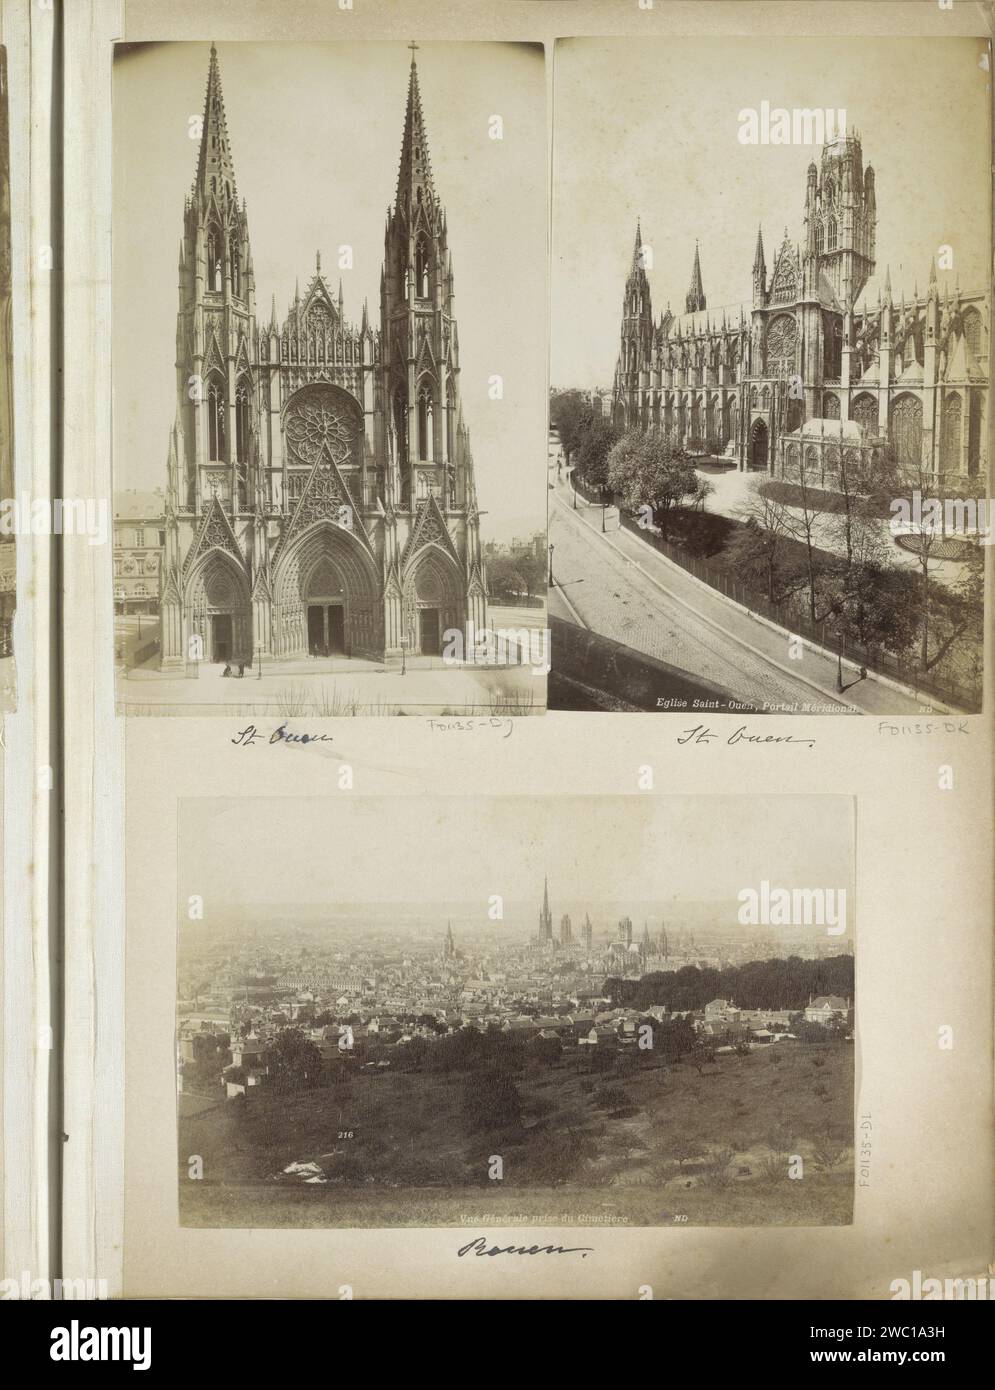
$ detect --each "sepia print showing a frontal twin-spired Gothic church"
[113,42,549,716]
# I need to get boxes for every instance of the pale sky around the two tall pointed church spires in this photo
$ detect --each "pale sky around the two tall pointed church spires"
[114,43,548,539]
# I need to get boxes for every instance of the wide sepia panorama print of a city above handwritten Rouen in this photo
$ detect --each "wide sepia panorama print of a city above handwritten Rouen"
[173,795,855,1236]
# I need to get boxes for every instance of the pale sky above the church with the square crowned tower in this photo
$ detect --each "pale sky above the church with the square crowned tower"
[550,38,991,386]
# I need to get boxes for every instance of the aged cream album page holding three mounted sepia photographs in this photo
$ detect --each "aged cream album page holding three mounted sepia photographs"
[63,0,994,1300]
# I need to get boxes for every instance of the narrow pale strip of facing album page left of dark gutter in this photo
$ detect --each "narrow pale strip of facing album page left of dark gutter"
[0,0,54,1297]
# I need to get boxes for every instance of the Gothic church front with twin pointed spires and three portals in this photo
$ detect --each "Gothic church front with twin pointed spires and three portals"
[160,49,486,669]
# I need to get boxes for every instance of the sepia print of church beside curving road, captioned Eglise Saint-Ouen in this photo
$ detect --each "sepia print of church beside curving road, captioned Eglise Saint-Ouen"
[548,36,992,716]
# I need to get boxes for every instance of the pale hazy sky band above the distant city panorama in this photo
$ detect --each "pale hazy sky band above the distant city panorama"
[179,794,853,927]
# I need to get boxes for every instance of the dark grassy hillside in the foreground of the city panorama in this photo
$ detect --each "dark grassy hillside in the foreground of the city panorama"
[178,1043,853,1226]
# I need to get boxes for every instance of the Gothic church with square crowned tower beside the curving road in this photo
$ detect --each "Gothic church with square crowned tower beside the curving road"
[611,133,989,487]
